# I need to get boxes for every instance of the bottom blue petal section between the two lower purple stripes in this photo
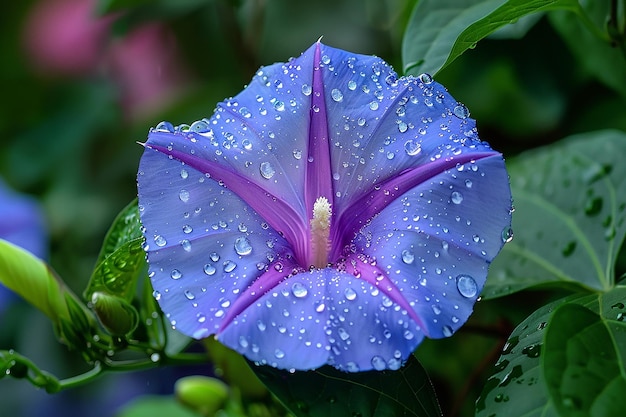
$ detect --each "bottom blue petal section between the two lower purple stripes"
[218,268,423,372]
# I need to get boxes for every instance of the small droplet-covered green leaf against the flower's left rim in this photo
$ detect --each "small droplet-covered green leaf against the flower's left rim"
[84,200,147,302]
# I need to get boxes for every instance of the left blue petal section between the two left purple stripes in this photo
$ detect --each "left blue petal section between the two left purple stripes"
[138,148,290,338]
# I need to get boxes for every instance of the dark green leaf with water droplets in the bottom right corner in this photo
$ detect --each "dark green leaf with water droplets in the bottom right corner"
[476,286,626,417]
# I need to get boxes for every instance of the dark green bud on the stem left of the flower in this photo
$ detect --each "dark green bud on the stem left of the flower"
[91,292,139,336]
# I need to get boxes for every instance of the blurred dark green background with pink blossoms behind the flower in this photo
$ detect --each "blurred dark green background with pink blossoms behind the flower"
[0,0,626,417]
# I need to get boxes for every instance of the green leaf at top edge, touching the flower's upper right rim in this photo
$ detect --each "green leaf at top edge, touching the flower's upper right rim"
[402,0,579,75]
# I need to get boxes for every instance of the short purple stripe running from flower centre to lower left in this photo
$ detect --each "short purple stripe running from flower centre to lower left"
[217,259,302,335]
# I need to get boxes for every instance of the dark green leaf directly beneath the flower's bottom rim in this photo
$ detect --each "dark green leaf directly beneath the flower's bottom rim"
[253,357,441,417]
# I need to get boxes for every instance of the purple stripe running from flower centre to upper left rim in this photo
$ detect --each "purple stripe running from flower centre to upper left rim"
[145,140,308,261]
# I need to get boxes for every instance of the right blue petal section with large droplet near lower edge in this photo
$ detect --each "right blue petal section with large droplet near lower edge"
[354,155,511,338]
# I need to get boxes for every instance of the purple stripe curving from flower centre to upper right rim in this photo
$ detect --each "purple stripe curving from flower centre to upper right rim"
[329,151,502,260]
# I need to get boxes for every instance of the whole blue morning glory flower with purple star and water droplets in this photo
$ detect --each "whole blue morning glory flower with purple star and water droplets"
[138,42,511,372]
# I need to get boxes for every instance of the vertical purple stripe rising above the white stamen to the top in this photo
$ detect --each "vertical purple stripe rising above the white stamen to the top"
[302,41,334,265]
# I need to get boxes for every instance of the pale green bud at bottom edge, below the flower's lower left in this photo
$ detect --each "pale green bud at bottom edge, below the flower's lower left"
[174,375,228,417]
